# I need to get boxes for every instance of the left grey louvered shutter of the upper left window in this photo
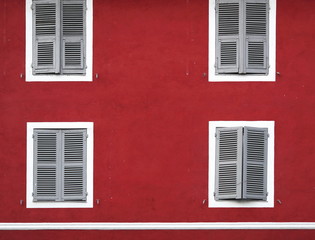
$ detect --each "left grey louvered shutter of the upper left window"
[32,0,60,74]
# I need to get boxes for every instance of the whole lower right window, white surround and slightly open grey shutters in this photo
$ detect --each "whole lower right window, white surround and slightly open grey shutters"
[209,121,274,207]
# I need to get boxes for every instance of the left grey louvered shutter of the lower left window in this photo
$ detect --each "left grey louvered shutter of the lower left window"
[33,130,60,201]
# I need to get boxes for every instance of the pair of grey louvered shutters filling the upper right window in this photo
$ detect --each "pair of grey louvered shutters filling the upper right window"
[215,0,269,74]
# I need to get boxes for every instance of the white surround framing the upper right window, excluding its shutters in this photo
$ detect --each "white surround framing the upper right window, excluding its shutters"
[208,0,277,82]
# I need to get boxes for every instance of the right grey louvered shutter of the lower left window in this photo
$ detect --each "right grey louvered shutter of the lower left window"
[62,129,87,200]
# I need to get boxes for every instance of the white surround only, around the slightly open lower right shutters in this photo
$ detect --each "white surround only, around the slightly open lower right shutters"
[208,121,275,208]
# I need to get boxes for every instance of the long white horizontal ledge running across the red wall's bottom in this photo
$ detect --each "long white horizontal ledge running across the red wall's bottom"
[0,222,315,230]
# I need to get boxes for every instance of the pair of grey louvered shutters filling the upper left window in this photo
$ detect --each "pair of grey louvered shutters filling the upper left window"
[31,0,86,75]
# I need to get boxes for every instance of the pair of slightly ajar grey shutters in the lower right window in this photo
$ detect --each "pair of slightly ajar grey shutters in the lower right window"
[214,127,268,200]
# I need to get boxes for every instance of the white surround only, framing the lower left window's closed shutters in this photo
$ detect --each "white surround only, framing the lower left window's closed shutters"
[26,122,94,208]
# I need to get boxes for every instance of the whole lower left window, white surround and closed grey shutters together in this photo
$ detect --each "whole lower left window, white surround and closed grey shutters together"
[27,123,93,207]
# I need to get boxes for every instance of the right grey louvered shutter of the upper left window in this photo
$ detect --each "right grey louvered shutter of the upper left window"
[60,0,87,74]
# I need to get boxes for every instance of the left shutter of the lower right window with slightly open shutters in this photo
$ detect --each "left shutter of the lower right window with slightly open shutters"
[215,127,243,200]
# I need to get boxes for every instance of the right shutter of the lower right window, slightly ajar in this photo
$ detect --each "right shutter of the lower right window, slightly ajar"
[243,127,268,200]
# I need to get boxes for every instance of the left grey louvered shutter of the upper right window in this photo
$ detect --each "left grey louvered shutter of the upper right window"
[215,0,242,74]
